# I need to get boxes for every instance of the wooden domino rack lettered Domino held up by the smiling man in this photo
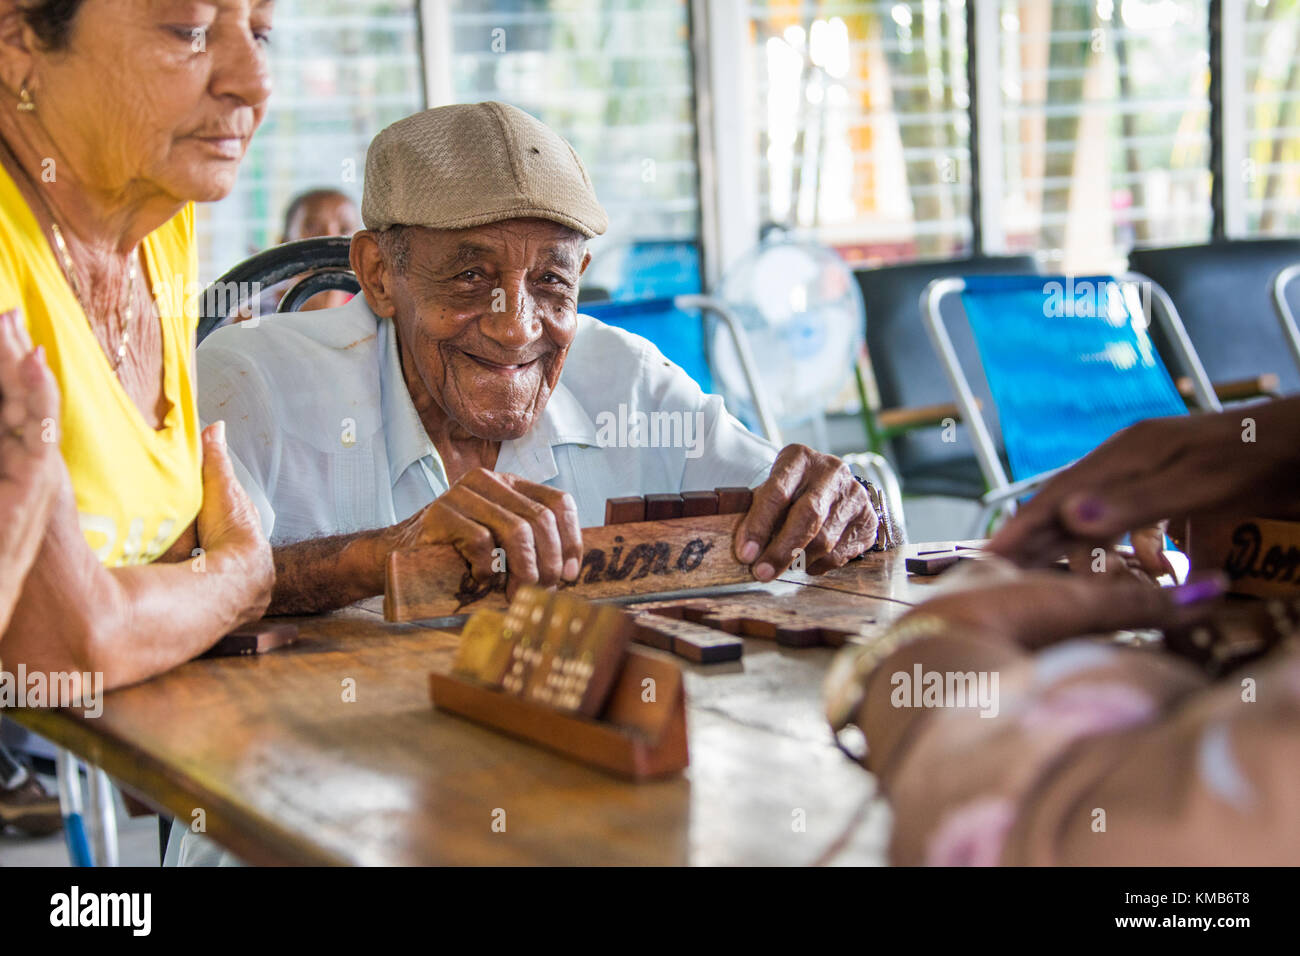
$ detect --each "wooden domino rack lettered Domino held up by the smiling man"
[384,515,754,620]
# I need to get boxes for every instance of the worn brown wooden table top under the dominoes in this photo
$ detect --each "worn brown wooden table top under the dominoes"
[5,545,951,865]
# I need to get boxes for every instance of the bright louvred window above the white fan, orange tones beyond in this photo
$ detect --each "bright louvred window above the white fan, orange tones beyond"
[748,0,972,263]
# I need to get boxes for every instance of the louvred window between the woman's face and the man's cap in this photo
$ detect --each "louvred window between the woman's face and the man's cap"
[198,0,424,282]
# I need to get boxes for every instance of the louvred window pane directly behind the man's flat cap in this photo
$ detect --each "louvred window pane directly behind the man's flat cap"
[449,0,699,291]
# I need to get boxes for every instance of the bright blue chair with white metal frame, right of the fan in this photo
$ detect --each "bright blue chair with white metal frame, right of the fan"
[922,274,1219,524]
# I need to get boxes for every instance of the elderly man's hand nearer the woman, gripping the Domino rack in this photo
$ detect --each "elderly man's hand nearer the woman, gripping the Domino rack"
[382,468,582,596]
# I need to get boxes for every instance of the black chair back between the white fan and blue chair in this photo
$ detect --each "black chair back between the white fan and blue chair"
[854,256,1040,498]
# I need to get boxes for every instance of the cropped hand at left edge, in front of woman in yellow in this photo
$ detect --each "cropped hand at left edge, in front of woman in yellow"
[0,312,64,635]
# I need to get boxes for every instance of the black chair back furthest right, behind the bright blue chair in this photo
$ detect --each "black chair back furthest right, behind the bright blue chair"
[1128,239,1300,394]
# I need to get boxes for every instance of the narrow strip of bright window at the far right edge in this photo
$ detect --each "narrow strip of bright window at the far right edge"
[1243,0,1300,235]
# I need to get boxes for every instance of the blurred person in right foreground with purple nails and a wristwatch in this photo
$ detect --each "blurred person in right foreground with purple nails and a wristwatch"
[827,398,1300,865]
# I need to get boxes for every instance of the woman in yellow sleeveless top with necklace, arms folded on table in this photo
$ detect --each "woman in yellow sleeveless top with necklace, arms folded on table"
[0,0,274,687]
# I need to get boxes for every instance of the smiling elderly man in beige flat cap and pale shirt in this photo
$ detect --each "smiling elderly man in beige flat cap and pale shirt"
[198,103,879,613]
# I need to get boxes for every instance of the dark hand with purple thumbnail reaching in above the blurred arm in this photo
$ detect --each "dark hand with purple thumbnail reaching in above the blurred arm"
[989,398,1300,575]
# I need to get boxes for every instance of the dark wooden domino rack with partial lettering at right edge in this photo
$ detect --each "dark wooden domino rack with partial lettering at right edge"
[1187,518,1300,597]
